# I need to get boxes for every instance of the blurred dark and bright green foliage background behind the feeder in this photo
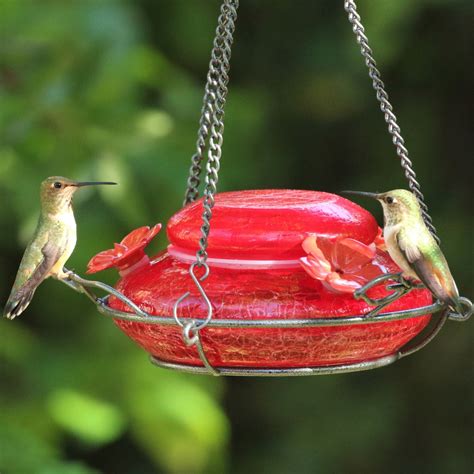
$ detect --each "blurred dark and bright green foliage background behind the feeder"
[0,0,474,474]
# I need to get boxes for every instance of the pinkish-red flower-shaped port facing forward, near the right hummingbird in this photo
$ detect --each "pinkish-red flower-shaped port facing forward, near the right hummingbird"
[300,235,383,293]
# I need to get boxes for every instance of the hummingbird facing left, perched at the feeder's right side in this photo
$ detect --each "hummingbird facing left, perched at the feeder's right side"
[343,189,462,314]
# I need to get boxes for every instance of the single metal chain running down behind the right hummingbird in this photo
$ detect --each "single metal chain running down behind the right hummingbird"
[344,0,440,243]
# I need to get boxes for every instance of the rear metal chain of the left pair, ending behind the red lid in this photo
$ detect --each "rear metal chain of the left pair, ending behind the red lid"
[183,0,239,205]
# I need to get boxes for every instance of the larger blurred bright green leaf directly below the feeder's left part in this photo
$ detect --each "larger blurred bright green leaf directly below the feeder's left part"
[128,368,229,473]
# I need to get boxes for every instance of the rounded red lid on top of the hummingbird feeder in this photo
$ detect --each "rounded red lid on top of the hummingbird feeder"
[167,189,378,260]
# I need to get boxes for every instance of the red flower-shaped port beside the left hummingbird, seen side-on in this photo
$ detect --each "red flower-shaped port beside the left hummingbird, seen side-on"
[87,224,161,276]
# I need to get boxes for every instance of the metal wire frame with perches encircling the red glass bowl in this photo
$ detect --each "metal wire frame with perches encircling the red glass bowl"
[62,272,473,377]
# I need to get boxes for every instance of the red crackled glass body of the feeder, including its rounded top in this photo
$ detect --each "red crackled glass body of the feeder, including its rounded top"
[91,190,432,373]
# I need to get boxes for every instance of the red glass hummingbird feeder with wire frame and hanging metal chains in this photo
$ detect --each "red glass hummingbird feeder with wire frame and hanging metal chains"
[62,0,472,376]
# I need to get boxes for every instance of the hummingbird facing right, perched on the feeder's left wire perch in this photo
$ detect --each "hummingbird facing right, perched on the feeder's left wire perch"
[3,176,117,319]
